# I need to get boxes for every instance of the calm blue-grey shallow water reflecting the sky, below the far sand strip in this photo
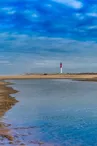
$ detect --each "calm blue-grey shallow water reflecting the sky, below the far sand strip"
[4,79,97,146]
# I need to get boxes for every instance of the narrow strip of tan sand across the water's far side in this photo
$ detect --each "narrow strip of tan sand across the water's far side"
[0,73,97,81]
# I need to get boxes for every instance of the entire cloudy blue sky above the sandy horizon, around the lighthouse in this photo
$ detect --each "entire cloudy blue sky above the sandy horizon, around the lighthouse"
[0,0,97,75]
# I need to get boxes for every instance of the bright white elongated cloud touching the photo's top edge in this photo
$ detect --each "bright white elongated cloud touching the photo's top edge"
[53,0,83,9]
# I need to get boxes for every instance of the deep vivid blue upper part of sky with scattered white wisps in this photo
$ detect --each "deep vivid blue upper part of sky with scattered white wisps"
[0,0,97,40]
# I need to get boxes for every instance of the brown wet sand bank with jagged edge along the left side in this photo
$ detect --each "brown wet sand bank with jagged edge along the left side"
[0,81,17,145]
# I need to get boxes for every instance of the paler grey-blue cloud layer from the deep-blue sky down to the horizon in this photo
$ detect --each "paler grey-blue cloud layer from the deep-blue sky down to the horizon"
[0,33,97,74]
